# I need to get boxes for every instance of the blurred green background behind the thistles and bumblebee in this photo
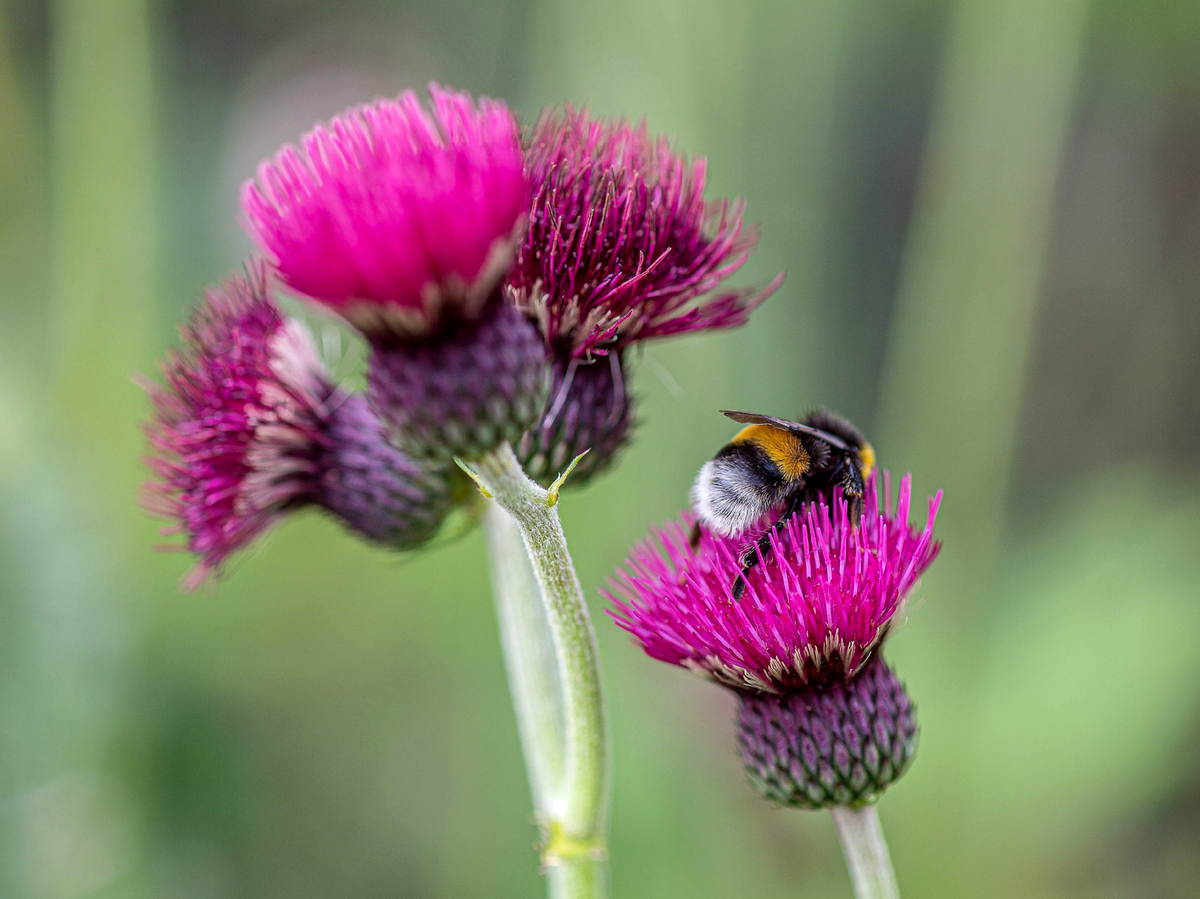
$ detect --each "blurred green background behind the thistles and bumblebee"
[0,0,1200,899]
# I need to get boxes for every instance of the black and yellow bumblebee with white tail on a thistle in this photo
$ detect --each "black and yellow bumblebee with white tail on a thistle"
[691,409,875,599]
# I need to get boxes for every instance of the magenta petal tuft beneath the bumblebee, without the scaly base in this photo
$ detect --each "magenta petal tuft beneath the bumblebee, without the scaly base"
[606,475,942,694]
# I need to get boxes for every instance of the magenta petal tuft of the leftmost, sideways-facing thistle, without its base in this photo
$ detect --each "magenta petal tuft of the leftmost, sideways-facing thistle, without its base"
[143,263,328,589]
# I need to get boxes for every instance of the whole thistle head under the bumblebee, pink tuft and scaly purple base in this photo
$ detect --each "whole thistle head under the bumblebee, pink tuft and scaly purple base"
[606,475,941,808]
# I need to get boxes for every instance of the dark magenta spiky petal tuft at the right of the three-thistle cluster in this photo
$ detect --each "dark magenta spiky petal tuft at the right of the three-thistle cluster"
[508,106,782,358]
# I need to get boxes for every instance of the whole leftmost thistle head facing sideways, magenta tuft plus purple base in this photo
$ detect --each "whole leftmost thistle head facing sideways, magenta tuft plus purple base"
[143,262,449,589]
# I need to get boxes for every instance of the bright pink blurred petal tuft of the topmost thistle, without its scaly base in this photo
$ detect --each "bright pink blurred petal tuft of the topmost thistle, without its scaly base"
[241,85,526,336]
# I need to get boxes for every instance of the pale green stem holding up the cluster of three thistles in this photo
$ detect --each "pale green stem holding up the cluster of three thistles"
[470,444,608,899]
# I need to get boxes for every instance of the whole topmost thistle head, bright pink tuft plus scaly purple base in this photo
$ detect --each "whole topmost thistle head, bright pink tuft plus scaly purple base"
[242,85,548,459]
